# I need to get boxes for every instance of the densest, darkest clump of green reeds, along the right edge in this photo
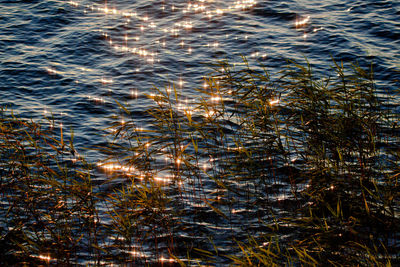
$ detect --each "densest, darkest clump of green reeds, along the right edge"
[282,59,400,265]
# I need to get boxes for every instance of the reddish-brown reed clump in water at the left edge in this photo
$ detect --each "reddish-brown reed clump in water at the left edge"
[0,109,98,266]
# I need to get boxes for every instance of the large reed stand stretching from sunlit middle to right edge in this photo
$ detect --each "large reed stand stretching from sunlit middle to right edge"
[110,58,400,266]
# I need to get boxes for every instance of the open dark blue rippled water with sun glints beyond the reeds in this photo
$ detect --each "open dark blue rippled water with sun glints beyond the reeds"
[0,0,400,161]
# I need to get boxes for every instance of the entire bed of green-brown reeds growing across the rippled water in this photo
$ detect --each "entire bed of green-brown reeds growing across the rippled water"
[0,58,400,266]
